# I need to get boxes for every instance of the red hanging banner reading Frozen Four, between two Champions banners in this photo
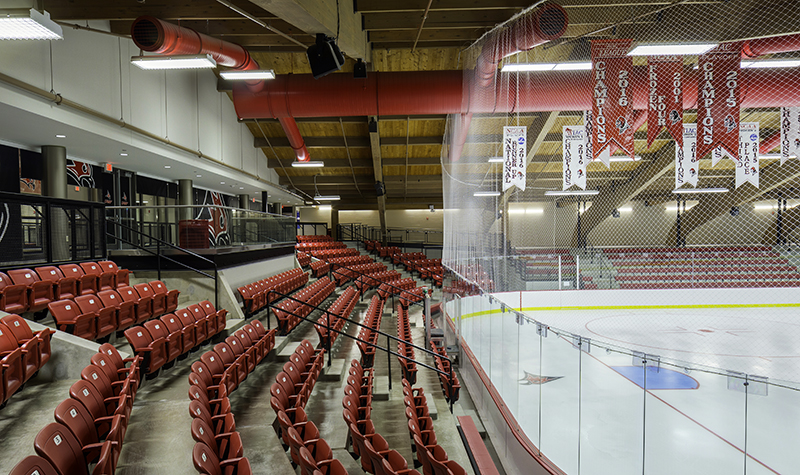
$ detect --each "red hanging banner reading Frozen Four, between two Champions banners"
[647,56,684,150]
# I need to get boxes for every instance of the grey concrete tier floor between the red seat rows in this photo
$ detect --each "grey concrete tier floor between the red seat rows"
[0,258,500,475]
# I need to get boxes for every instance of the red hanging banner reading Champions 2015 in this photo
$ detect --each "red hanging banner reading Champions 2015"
[697,43,742,166]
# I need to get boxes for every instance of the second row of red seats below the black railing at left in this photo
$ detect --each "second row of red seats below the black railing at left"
[47,280,180,340]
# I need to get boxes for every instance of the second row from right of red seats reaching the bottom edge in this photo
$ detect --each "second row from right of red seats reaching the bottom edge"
[342,360,419,475]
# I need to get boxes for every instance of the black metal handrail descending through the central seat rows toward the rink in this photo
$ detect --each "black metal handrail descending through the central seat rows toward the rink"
[267,284,455,412]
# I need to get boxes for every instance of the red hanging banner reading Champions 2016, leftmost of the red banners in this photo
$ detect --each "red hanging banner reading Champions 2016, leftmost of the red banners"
[592,40,634,167]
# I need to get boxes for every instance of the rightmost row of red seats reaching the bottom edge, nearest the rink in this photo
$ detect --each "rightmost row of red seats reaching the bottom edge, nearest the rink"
[403,379,467,475]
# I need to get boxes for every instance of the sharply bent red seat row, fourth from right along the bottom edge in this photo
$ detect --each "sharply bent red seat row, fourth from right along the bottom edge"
[189,320,275,475]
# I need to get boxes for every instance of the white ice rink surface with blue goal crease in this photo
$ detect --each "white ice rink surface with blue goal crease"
[455,304,800,475]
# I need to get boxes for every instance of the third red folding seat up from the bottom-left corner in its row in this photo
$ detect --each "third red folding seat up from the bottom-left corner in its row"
[53,398,126,473]
